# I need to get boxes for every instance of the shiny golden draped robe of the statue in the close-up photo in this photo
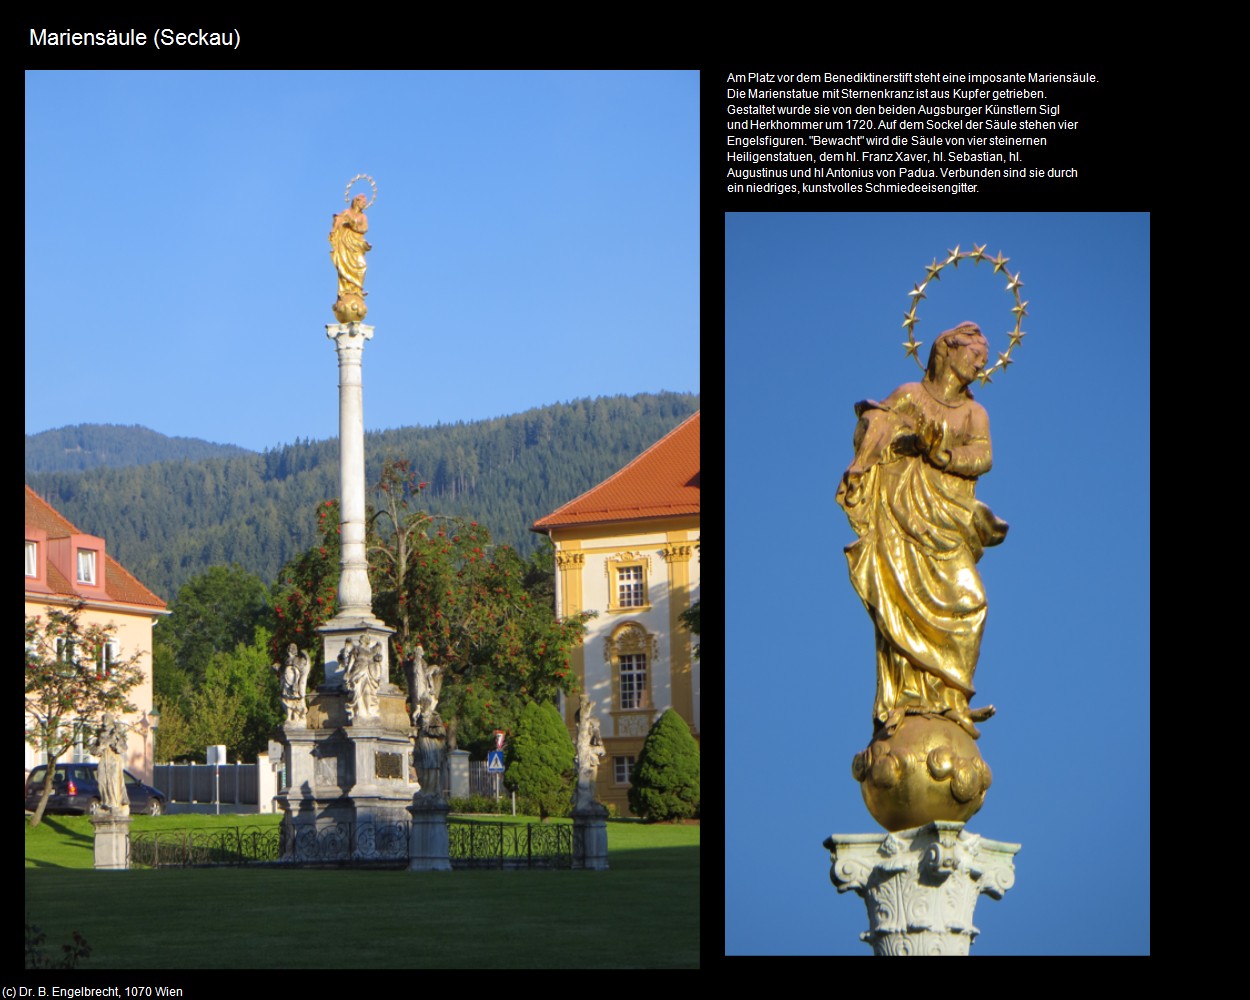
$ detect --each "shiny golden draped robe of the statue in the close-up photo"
[838,383,1008,725]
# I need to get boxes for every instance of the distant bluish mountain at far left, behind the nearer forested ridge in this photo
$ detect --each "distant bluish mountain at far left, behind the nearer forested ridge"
[26,424,255,476]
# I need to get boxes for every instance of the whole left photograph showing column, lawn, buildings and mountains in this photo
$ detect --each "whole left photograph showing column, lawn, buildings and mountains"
[25,71,701,970]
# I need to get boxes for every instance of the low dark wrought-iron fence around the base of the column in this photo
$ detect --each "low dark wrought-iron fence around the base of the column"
[130,820,573,869]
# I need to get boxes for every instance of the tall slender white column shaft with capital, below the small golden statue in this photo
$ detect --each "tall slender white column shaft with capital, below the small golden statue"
[325,323,374,618]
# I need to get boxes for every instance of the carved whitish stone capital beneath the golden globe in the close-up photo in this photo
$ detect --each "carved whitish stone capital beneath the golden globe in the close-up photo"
[825,820,1020,955]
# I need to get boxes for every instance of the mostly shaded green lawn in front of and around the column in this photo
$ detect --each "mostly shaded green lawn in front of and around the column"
[25,815,699,970]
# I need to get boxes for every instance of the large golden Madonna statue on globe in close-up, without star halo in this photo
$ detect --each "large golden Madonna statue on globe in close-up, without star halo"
[838,323,1008,830]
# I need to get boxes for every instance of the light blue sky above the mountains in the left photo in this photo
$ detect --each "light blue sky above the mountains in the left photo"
[25,71,700,449]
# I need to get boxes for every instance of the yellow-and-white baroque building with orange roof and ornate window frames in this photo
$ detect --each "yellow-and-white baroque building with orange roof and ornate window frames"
[533,413,699,816]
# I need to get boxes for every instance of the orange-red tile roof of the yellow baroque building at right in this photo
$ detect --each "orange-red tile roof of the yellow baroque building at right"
[531,413,699,531]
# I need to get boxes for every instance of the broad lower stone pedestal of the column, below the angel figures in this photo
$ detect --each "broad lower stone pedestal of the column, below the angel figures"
[275,689,420,861]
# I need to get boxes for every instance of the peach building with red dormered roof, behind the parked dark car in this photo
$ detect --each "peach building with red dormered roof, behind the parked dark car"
[24,486,169,784]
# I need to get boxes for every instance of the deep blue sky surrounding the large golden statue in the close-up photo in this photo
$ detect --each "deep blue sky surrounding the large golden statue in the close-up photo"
[725,213,1150,955]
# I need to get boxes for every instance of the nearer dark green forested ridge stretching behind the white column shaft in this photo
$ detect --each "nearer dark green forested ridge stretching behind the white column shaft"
[26,393,699,600]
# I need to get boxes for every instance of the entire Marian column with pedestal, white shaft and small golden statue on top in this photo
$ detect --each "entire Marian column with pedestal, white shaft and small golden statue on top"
[276,175,420,861]
